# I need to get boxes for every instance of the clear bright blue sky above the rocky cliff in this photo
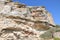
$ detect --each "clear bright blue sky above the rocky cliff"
[14,0,60,25]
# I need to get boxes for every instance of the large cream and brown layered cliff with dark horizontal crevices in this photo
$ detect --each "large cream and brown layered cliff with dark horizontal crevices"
[0,0,55,40]
